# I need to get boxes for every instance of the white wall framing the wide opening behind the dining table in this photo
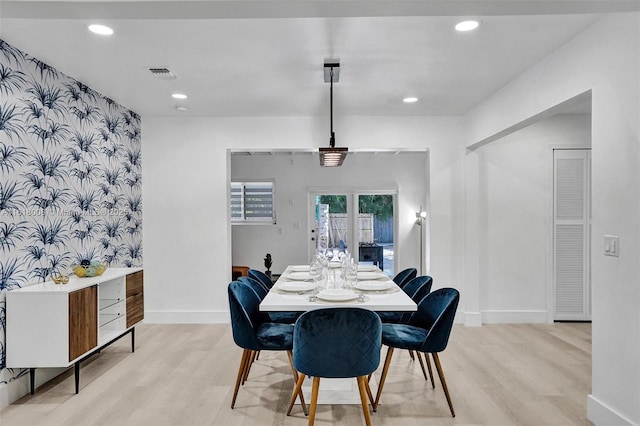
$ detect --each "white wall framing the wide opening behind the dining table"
[142,117,462,322]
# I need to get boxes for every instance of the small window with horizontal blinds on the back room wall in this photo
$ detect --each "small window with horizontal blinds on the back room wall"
[230,182,276,225]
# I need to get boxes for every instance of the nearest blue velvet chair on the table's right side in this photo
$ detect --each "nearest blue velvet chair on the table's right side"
[373,288,460,417]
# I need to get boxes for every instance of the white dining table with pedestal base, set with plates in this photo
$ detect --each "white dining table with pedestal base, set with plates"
[260,265,417,404]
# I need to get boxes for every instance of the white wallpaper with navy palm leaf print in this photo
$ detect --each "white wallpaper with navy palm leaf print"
[0,39,142,386]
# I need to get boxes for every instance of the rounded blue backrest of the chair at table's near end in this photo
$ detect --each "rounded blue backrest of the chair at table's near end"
[293,308,382,378]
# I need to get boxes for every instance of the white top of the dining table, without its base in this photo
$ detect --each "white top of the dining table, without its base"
[260,267,417,311]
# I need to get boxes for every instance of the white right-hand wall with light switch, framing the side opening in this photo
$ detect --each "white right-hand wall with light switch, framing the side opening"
[465,13,640,425]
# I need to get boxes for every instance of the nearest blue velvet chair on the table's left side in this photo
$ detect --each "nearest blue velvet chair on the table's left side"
[228,281,307,414]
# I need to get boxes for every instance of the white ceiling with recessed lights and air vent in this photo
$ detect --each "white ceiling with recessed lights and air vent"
[0,0,640,118]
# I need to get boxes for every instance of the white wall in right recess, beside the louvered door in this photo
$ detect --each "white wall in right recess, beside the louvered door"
[478,115,591,323]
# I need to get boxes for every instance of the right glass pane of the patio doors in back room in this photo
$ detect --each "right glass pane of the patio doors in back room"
[357,194,394,276]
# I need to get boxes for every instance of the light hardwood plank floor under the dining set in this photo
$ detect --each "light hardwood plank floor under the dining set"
[0,323,591,426]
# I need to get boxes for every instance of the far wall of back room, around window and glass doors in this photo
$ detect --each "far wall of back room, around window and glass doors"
[231,152,429,273]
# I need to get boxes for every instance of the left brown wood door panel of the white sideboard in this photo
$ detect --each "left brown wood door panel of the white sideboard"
[69,285,98,361]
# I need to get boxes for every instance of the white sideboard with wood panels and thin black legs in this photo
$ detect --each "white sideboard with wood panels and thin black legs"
[6,268,144,394]
